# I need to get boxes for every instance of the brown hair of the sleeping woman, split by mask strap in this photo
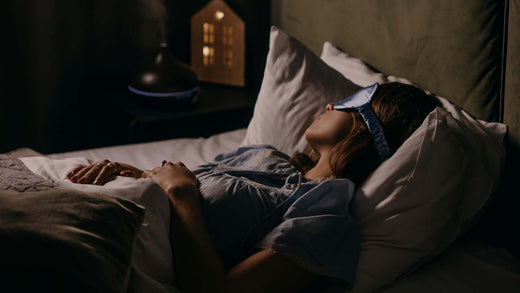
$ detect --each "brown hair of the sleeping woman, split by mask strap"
[292,82,440,184]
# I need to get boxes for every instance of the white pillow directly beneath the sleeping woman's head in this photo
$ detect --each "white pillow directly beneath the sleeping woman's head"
[351,107,470,292]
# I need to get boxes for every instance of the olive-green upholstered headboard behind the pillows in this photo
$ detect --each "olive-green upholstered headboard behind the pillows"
[272,0,520,253]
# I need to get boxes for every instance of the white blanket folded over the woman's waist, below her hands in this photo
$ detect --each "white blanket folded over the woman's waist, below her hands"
[21,157,178,292]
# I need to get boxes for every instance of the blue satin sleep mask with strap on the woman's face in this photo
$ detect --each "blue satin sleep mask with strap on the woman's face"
[334,83,391,162]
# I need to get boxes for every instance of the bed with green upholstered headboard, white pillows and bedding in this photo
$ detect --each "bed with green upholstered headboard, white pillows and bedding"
[0,0,520,292]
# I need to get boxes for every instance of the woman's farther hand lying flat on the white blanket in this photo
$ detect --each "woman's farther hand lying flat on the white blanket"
[67,159,143,185]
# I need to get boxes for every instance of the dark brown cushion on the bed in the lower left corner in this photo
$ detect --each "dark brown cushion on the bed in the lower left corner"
[0,189,144,292]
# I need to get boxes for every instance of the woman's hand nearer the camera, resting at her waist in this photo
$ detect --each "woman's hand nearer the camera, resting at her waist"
[142,162,200,209]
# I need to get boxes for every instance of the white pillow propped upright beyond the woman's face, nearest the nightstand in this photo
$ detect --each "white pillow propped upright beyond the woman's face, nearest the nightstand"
[241,26,361,155]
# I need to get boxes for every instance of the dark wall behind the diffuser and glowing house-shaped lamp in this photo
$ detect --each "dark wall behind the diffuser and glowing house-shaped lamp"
[0,0,270,153]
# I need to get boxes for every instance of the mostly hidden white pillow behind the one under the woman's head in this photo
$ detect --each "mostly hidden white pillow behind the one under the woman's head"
[321,42,507,226]
